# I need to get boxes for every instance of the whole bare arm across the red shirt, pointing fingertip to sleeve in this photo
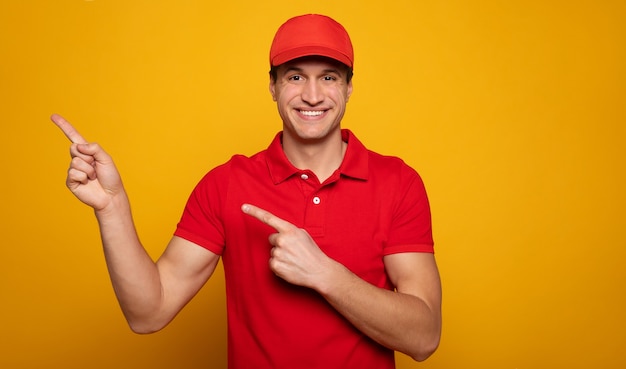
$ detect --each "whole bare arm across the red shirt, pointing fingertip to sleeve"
[242,204,441,361]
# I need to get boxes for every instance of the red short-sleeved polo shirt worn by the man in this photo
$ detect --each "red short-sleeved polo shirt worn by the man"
[175,130,433,369]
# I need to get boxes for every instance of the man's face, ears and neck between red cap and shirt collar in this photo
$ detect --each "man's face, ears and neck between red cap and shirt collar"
[269,58,352,182]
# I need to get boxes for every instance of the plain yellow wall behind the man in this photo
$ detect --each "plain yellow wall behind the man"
[0,0,626,369]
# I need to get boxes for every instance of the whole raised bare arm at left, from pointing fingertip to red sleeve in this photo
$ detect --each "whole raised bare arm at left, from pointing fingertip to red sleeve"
[51,115,219,333]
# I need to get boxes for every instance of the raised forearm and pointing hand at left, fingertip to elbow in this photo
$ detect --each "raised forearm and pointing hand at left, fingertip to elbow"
[51,115,179,332]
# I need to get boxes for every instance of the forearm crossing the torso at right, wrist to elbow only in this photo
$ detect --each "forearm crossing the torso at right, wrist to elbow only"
[316,263,441,361]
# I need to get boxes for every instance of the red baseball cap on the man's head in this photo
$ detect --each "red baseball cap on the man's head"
[270,14,354,69]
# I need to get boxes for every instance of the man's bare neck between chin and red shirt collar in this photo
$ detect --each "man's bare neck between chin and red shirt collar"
[283,130,348,182]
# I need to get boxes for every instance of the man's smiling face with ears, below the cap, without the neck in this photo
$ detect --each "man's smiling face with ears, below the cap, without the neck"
[270,57,352,142]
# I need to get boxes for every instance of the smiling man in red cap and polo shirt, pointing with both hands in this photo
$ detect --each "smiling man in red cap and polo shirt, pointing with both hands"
[52,14,441,368]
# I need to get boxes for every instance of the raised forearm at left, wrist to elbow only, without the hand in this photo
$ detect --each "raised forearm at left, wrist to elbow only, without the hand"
[95,193,164,333]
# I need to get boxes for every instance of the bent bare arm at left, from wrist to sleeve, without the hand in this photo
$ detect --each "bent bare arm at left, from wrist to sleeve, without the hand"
[96,200,219,334]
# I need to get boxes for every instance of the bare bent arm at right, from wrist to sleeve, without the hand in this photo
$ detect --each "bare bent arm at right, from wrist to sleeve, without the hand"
[317,253,441,361]
